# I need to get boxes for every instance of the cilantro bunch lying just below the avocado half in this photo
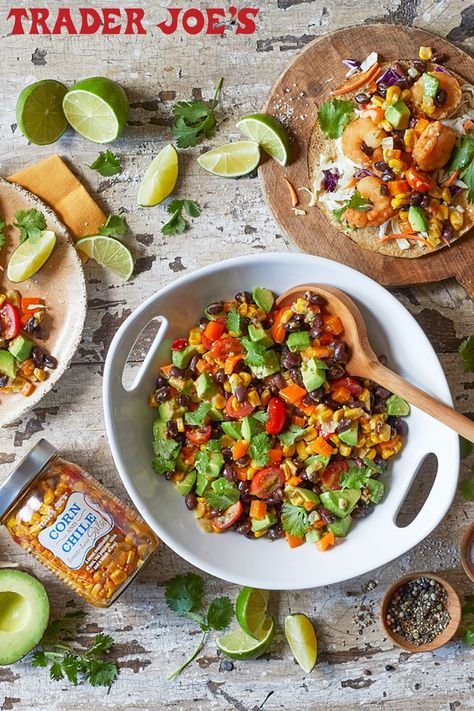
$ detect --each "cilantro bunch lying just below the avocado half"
[33,610,119,686]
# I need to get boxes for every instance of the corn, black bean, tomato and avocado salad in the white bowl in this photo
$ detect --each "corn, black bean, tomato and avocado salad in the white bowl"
[150,287,409,550]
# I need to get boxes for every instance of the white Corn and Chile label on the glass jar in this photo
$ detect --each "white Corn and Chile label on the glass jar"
[38,491,114,570]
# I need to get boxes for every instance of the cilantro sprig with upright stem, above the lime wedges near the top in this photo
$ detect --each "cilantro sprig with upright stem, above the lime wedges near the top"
[171,78,224,148]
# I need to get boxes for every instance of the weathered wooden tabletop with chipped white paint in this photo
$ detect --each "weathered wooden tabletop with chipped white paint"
[0,0,474,711]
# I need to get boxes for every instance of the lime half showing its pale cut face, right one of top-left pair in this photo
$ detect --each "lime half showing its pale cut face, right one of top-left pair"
[63,77,129,143]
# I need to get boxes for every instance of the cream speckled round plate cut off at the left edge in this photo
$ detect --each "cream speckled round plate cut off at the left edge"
[0,179,87,427]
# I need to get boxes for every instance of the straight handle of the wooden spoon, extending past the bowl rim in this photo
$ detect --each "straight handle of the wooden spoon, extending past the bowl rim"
[367,362,474,442]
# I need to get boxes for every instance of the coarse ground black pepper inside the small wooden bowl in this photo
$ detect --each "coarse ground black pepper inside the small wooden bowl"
[386,577,451,645]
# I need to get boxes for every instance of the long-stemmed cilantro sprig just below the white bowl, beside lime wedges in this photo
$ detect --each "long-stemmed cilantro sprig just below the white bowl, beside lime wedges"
[165,573,234,681]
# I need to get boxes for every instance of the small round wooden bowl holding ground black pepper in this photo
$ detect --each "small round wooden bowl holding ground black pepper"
[380,573,462,652]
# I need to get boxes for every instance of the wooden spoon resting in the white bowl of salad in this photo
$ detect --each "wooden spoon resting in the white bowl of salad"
[276,284,474,442]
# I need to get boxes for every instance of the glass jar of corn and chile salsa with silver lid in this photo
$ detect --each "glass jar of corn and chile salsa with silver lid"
[0,439,158,607]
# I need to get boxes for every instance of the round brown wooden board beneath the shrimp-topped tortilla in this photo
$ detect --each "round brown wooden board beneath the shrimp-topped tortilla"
[260,24,474,298]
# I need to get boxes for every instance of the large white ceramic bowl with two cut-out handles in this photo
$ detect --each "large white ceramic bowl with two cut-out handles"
[104,254,459,590]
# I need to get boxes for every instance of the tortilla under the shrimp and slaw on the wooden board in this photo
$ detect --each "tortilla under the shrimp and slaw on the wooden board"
[308,60,474,259]
